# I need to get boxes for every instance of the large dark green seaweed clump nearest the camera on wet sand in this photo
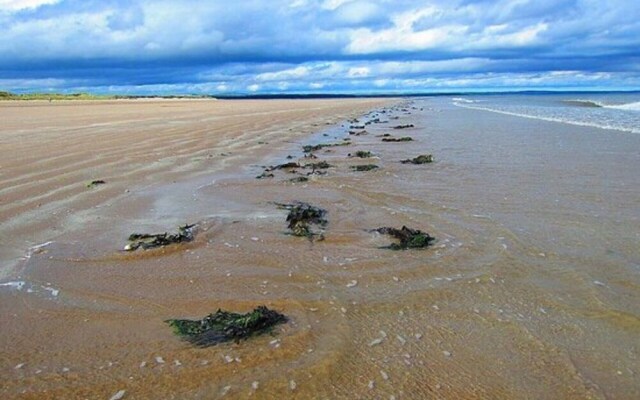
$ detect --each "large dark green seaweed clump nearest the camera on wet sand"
[165,306,287,347]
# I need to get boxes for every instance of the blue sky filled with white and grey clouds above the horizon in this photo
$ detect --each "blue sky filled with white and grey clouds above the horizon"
[0,0,640,94]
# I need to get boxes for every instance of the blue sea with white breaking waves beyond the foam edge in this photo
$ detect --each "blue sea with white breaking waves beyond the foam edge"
[451,92,640,133]
